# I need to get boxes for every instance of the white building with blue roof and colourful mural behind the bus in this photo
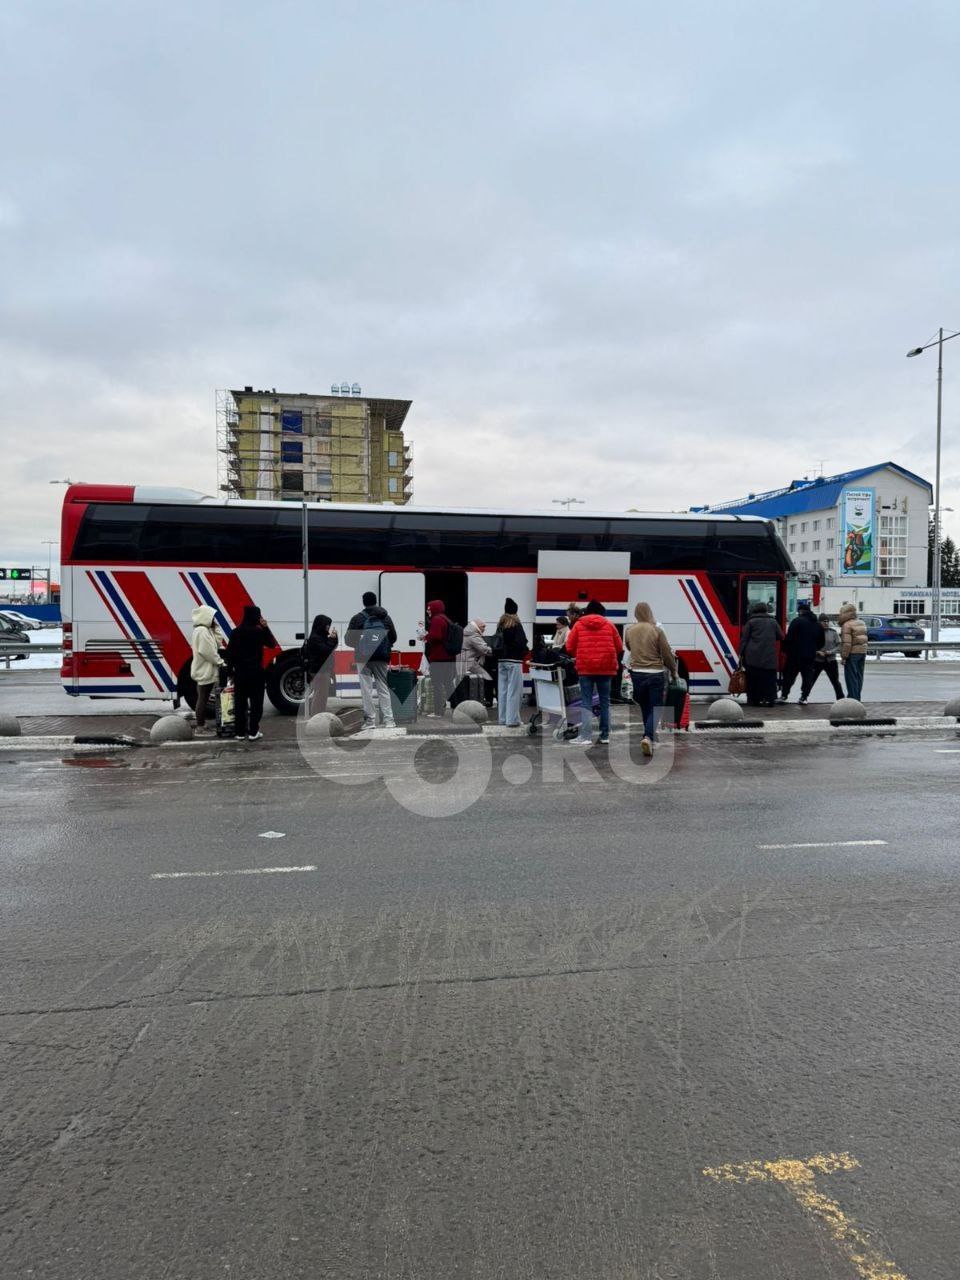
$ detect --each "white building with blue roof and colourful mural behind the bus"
[691,462,942,617]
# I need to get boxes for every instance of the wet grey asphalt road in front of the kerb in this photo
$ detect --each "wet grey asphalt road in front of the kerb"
[0,736,960,1280]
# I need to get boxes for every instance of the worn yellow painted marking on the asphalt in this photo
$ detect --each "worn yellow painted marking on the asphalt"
[704,1151,906,1280]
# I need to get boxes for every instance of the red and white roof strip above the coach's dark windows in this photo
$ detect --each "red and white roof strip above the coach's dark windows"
[64,484,769,525]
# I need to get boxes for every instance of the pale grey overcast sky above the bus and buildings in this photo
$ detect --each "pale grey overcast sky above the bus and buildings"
[0,0,960,563]
